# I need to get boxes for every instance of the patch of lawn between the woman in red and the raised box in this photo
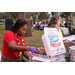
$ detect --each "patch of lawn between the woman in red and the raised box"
[24,31,44,47]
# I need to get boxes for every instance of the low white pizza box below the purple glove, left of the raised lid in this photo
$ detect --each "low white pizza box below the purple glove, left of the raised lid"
[29,51,51,62]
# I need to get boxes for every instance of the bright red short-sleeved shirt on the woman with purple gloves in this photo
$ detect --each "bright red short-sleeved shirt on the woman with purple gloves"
[2,31,26,59]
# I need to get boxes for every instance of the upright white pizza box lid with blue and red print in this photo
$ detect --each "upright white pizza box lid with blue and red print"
[42,28,66,56]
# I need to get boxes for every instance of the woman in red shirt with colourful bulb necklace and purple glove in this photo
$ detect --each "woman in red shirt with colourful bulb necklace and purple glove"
[1,19,39,62]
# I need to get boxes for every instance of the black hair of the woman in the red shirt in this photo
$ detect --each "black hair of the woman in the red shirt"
[10,19,27,31]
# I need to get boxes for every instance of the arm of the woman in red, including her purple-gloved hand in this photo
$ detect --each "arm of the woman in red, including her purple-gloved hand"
[7,41,39,54]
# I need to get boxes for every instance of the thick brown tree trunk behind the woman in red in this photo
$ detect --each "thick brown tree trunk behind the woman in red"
[10,12,32,37]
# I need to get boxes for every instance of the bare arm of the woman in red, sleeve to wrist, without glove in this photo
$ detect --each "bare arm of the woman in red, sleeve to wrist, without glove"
[7,41,28,52]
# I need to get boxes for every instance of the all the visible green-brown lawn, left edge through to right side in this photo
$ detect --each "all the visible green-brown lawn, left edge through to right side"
[0,25,74,60]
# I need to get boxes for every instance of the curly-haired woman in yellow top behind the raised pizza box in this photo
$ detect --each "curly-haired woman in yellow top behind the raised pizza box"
[48,15,63,38]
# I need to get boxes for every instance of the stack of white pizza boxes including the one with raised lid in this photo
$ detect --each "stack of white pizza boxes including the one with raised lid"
[29,28,66,62]
